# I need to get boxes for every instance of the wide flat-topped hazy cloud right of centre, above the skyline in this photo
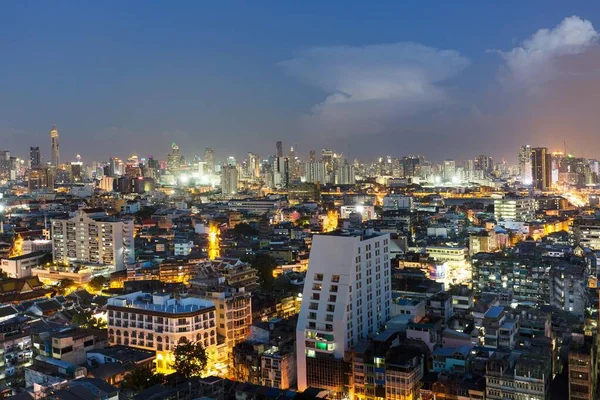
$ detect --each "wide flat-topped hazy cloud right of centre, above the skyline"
[280,42,469,135]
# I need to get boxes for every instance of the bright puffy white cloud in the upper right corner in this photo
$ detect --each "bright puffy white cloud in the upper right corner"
[492,16,598,88]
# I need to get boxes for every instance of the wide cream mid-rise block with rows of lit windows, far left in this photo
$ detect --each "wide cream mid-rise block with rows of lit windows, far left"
[52,208,134,271]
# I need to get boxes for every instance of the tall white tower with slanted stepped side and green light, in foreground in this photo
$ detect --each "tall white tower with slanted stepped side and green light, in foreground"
[296,230,392,398]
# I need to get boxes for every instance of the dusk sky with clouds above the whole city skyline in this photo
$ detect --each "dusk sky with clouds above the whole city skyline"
[0,0,600,162]
